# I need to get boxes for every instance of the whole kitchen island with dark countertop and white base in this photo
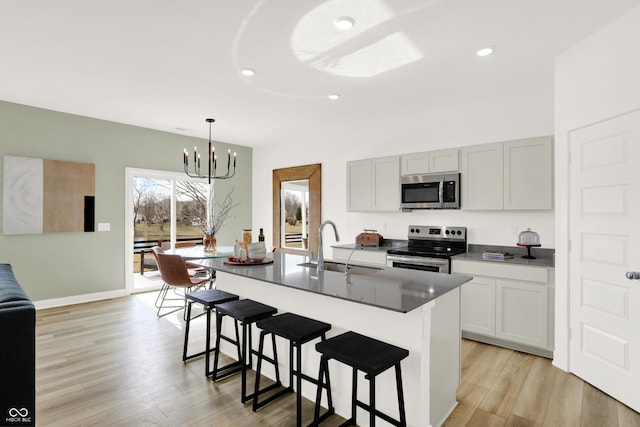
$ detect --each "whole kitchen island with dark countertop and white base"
[190,253,471,426]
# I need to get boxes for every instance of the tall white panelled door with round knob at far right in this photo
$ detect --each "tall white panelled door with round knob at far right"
[569,112,640,411]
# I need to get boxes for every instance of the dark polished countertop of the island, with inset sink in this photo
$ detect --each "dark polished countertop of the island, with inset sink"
[190,253,471,313]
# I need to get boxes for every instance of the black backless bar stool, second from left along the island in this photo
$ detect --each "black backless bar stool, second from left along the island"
[211,299,278,403]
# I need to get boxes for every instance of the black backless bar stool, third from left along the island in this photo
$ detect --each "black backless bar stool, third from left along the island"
[253,313,334,426]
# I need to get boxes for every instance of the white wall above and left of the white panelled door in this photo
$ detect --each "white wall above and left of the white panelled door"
[554,2,640,370]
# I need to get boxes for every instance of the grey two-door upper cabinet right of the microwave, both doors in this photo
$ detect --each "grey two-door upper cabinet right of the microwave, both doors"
[460,136,553,210]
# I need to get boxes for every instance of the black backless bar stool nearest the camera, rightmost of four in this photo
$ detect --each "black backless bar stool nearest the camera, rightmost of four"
[313,331,409,426]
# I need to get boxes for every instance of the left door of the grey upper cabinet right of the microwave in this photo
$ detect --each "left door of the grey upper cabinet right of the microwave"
[461,143,504,210]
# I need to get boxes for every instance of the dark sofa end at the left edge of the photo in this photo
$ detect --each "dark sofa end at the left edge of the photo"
[0,264,36,426]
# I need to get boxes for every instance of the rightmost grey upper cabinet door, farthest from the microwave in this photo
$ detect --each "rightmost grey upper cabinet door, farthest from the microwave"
[504,136,553,210]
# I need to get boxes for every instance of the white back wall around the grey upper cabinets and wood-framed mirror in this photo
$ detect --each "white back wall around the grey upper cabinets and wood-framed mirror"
[253,82,555,254]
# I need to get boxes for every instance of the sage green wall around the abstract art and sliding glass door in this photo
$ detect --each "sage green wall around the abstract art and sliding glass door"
[0,101,252,301]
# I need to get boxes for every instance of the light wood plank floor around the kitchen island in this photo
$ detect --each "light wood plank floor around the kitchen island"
[36,294,640,427]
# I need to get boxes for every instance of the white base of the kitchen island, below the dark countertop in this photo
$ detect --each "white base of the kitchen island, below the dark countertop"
[216,267,460,427]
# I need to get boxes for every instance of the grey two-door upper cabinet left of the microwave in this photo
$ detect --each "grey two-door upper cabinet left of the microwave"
[347,156,400,212]
